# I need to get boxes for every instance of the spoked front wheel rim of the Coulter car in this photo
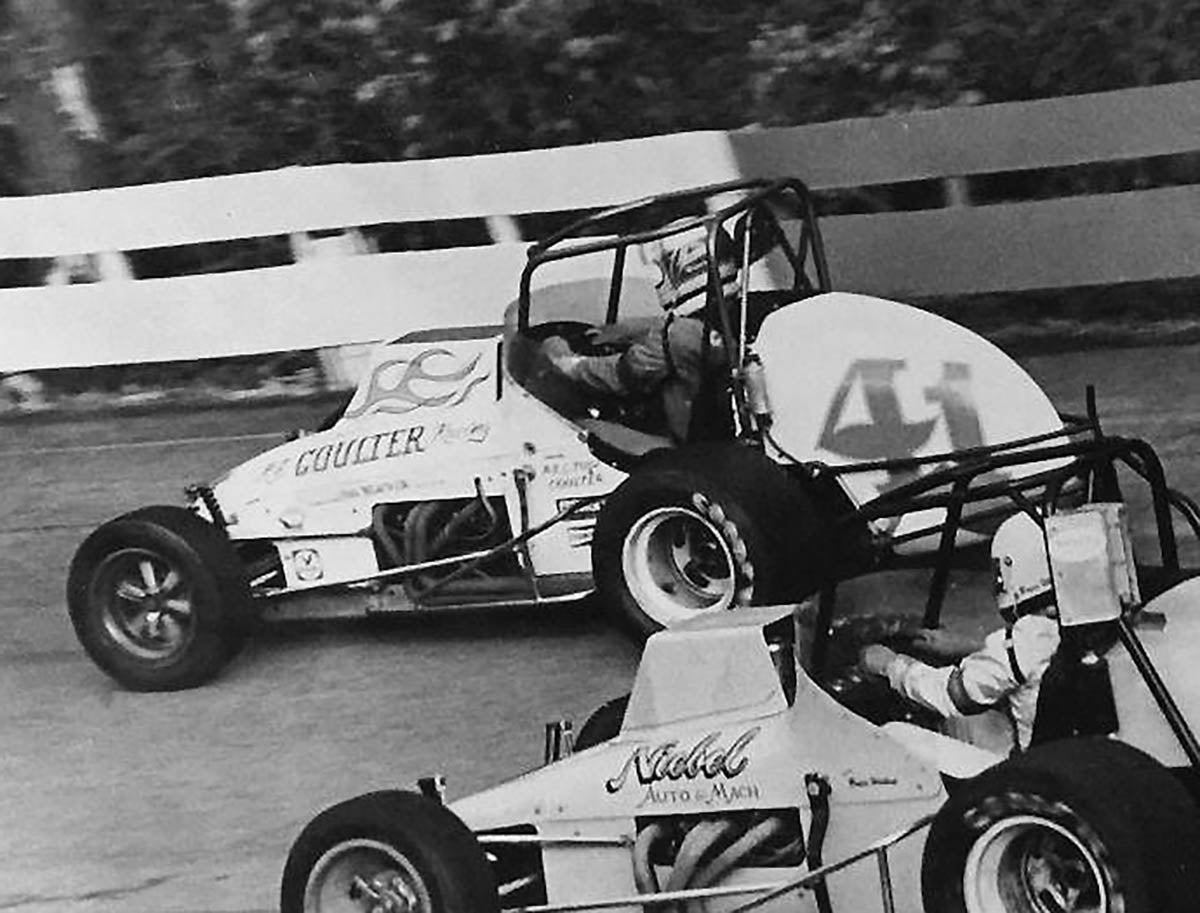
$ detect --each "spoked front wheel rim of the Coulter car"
[90,548,196,662]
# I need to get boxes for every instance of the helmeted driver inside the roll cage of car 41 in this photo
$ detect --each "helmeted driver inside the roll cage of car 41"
[541,217,740,442]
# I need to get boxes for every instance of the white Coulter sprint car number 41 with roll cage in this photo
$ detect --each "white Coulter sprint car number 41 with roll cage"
[67,179,1190,690]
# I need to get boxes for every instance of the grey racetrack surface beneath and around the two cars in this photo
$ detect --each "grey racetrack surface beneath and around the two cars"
[0,347,1200,913]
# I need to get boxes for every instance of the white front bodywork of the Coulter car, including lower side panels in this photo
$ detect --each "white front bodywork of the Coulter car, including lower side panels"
[201,332,625,588]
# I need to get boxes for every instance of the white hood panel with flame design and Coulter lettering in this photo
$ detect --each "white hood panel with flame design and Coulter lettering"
[214,337,504,539]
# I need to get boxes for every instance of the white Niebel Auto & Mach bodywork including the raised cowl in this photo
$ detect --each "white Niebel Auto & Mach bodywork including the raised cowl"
[450,607,955,912]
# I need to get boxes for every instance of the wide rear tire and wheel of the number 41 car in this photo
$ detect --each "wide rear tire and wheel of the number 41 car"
[592,444,822,638]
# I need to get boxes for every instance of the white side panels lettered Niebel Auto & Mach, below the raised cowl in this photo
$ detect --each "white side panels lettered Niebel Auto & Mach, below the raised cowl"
[452,657,944,913]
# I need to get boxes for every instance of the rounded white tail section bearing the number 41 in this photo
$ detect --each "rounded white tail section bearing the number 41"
[754,292,1064,535]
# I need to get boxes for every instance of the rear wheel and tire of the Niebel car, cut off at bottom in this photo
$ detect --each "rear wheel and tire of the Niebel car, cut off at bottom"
[922,738,1200,913]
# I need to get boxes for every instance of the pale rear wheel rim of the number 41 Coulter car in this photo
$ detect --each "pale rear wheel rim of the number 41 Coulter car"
[620,506,738,627]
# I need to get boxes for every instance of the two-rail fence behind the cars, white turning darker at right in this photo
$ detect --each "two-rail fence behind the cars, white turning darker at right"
[0,83,1200,372]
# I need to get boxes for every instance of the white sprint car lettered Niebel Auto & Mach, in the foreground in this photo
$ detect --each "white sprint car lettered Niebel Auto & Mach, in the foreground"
[281,487,1200,913]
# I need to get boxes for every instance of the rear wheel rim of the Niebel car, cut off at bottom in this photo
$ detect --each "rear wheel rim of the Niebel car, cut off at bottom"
[962,815,1108,913]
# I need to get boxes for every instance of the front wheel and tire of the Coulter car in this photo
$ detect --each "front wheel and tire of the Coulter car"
[67,506,251,691]
